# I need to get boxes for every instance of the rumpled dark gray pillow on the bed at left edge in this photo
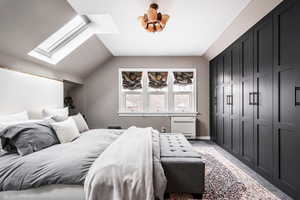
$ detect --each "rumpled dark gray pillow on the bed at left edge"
[0,122,59,156]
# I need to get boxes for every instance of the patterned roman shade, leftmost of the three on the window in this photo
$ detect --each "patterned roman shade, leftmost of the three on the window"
[122,71,143,90]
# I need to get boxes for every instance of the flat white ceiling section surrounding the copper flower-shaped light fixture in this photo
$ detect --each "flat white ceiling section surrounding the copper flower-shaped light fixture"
[68,0,251,56]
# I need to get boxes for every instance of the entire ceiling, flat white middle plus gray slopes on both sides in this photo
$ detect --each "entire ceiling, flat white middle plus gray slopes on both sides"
[0,0,282,79]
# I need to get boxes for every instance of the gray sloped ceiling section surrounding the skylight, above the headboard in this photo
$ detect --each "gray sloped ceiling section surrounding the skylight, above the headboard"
[0,0,112,77]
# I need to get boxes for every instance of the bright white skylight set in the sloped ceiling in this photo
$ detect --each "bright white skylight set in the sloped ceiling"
[28,15,91,64]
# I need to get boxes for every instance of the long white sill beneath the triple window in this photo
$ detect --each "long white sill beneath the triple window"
[118,112,199,117]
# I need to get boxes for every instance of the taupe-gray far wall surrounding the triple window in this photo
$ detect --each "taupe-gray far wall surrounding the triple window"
[69,56,209,136]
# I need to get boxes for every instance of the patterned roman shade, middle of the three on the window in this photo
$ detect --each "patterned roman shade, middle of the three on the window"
[148,72,168,89]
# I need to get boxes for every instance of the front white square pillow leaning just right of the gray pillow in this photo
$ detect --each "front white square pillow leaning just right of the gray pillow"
[51,117,80,143]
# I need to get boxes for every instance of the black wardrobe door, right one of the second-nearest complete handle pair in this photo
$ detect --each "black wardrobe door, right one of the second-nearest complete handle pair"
[230,43,240,155]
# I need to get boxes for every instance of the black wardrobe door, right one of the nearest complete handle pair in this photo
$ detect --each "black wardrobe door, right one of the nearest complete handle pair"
[254,16,273,178]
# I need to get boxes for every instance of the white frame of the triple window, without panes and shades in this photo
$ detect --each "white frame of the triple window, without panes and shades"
[118,67,197,117]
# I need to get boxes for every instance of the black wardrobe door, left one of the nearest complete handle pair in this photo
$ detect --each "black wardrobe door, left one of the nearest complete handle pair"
[240,31,254,166]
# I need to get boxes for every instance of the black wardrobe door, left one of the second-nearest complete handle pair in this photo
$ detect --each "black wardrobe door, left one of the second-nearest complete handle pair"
[223,48,232,151]
